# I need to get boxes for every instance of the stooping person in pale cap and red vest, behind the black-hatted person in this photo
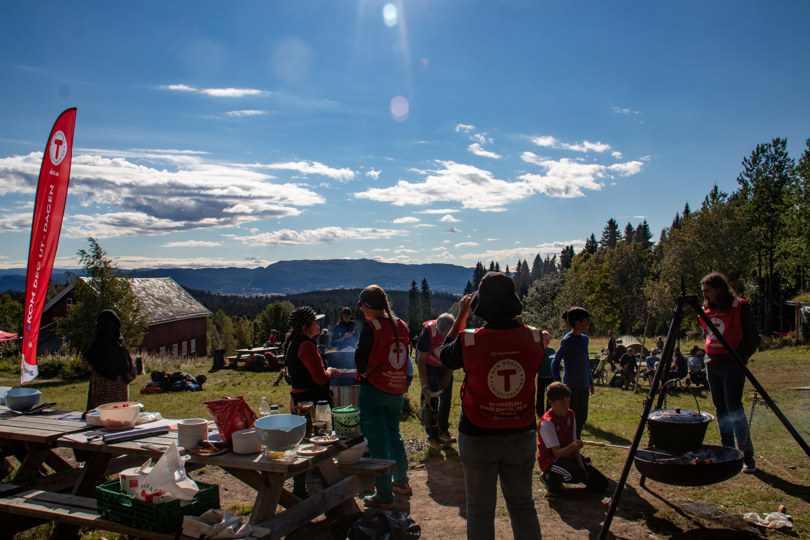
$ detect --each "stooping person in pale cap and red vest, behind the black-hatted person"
[416,313,456,450]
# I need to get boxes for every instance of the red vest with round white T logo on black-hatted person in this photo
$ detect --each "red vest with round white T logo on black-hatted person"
[461,325,544,429]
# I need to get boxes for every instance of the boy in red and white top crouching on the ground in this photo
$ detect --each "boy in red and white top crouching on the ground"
[537,382,608,496]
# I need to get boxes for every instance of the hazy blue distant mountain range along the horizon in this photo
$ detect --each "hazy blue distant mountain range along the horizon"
[0,259,473,295]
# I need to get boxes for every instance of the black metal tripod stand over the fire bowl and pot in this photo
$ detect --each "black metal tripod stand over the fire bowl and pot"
[599,292,810,540]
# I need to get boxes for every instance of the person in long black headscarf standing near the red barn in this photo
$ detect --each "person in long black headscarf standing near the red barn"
[84,309,135,411]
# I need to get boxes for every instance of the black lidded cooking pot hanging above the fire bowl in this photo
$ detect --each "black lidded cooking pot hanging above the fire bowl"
[647,409,714,452]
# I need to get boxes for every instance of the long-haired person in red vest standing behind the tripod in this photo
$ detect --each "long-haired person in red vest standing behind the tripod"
[700,272,759,473]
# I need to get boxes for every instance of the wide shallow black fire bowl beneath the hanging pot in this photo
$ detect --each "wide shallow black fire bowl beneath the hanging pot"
[633,445,743,486]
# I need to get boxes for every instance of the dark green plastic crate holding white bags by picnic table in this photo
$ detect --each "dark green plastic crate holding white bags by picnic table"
[96,482,219,532]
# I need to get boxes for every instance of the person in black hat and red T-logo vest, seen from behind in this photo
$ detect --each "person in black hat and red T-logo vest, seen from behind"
[440,272,544,539]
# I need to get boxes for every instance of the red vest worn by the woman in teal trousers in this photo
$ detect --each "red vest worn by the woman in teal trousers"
[368,318,409,394]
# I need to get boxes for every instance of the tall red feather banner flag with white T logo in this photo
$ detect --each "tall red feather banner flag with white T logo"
[20,107,76,383]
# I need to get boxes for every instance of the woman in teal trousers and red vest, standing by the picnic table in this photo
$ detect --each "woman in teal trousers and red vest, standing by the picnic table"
[354,285,412,510]
